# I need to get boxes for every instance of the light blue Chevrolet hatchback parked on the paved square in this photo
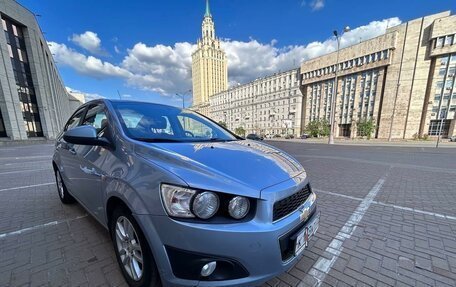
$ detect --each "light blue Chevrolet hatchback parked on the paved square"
[53,100,320,286]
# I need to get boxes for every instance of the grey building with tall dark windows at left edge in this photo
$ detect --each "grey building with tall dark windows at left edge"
[0,0,81,140]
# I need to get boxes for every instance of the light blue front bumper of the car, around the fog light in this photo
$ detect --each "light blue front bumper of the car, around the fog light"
[135,195,319,286]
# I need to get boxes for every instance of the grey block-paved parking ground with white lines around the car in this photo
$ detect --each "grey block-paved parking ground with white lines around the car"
[0,142,456,286]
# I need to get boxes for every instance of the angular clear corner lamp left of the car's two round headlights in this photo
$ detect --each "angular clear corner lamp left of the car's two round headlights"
[160,184,196,218]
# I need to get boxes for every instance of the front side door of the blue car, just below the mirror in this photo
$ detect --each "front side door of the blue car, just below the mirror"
[71,103,110,219]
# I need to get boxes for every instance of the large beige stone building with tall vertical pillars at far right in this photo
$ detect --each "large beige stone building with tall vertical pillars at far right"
[301,11,456,139]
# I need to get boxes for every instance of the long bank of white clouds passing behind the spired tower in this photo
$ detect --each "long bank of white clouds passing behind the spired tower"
[49,18,401,96]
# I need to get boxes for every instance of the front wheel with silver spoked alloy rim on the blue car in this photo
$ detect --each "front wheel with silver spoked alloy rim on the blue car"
[109,208,162,287]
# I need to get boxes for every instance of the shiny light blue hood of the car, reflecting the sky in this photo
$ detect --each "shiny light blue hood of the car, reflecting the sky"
[136,140,304,197]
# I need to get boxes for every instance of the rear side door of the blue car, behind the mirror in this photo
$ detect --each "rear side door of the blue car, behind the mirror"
[56,106,86,198]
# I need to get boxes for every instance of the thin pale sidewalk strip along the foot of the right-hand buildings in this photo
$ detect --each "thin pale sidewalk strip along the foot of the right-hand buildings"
[266,138,456,148]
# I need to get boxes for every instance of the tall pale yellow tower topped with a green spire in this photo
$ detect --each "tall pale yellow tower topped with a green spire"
[192,0,228,107]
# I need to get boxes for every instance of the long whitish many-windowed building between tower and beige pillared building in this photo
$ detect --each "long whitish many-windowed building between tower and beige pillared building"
[209,69,303,136]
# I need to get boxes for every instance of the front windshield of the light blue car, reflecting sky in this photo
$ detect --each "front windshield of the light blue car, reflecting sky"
[113,102,238,142]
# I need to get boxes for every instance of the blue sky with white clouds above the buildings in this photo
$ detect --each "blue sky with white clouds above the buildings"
[19,0,456,105]
